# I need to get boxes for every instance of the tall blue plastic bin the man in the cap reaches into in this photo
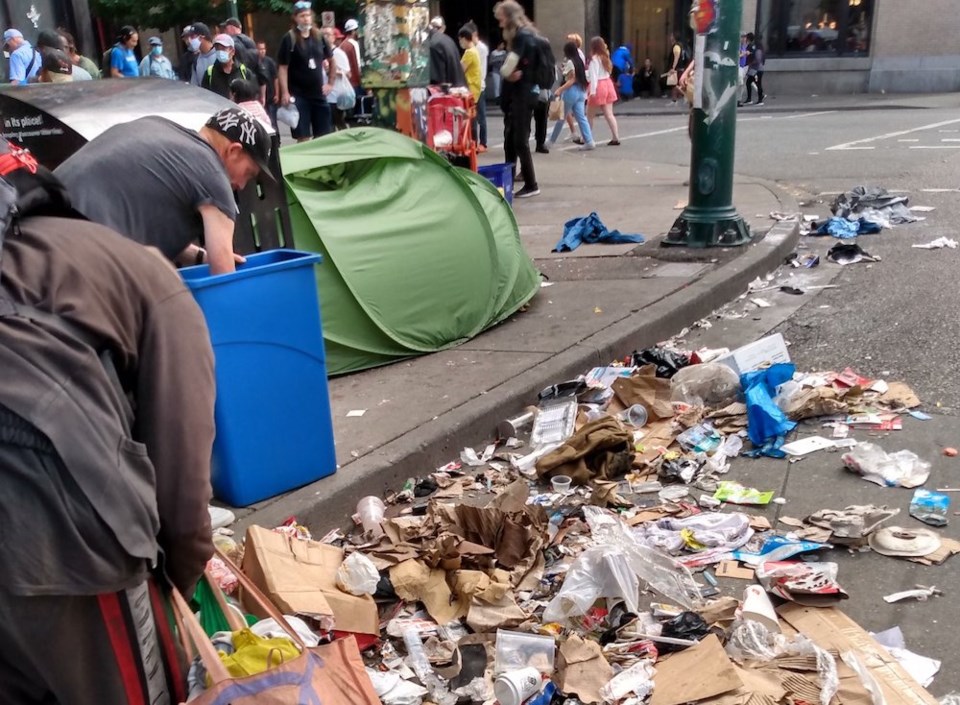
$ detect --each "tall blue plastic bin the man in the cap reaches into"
[180,250,337,507]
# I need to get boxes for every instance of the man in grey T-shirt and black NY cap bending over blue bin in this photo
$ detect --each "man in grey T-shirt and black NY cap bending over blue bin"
[55,106,273,274]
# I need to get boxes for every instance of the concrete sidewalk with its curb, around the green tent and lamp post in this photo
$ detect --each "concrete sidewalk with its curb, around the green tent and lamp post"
[239,148,797,526]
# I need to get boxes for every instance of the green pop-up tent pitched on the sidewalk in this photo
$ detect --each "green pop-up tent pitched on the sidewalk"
[280,127,539,374]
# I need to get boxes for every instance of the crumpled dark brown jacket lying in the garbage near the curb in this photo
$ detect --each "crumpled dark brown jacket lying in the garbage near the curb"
[537,416,633,485]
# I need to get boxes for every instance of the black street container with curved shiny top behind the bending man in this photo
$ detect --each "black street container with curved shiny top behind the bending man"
[0,78,293,254]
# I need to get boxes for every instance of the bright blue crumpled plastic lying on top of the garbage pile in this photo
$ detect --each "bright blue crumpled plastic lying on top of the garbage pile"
[740,362,797,458]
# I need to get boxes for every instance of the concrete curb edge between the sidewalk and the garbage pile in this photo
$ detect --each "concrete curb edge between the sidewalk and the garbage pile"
[233,195,800,532]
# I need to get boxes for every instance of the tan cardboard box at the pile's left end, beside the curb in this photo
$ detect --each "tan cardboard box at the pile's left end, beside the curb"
[243,526,380,635]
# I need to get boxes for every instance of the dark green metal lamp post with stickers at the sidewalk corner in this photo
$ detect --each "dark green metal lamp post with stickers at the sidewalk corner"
[661,0,750,247]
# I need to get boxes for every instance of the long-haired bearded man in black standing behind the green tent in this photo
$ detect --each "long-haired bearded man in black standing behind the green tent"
[493,0,540,198]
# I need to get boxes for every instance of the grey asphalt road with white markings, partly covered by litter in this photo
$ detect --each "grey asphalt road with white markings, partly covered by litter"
[521,95,960,696]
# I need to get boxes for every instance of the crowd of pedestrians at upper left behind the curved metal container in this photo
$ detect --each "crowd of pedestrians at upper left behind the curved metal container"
[3,0,366,141]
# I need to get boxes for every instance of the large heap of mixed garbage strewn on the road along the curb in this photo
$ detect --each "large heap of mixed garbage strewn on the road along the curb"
[201,328,960,705]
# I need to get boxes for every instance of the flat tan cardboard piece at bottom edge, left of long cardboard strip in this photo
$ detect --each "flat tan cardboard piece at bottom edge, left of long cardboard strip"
[650,634,743,705]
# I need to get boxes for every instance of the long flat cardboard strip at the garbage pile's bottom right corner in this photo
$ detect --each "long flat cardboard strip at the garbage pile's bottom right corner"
[777,603,938,705]
